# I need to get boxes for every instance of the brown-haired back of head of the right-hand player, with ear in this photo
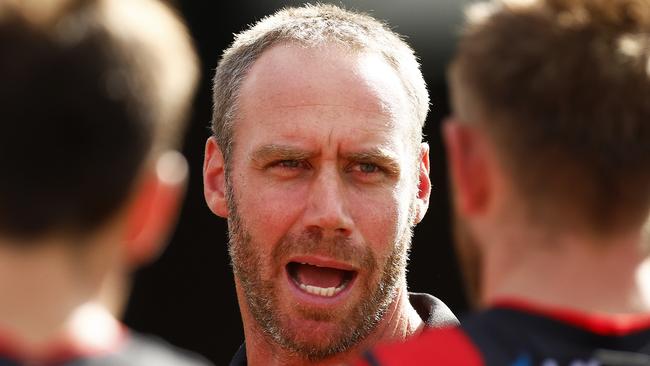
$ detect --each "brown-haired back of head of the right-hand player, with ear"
[445,0,650,304]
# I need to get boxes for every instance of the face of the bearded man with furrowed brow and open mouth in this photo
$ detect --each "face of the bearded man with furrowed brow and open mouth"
[218,45,420,359]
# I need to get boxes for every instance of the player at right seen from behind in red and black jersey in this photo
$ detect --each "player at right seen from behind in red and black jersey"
[356,0,650,366]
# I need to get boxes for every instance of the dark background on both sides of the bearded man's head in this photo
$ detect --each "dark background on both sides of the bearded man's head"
[125,0,470,365]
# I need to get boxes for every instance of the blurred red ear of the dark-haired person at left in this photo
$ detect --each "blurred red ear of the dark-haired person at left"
[124,151,188,266]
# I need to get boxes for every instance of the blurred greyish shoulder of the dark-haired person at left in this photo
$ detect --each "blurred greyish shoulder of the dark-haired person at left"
[75,332,211,366]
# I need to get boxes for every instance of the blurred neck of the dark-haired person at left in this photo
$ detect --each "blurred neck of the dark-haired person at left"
[0,242,121,360]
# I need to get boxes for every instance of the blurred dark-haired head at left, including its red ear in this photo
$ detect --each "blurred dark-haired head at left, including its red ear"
[0,0,197,292]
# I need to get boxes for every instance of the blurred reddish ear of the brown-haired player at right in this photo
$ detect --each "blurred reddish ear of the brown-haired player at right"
[442,120,491,217]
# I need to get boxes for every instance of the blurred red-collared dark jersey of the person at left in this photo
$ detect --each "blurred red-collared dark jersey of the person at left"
[0,329,211,366]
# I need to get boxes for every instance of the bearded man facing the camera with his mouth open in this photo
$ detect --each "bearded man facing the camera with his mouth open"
[203,5,456,365]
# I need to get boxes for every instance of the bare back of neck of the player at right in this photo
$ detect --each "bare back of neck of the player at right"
[483,227,650,314]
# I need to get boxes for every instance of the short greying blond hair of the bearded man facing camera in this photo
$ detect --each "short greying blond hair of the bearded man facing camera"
[212,4,429,161]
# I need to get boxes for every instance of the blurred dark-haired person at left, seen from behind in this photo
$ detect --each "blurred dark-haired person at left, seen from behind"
[0,0,207,366]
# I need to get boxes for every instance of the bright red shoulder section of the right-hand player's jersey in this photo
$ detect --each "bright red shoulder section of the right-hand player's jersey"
[358,327,483,366]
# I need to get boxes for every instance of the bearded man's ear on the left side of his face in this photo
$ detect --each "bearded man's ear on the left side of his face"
[203,137,228,218]
